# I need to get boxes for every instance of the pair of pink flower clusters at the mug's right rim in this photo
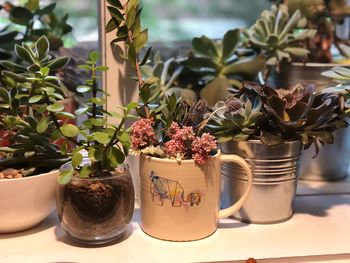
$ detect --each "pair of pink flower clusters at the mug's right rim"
[164,122,217,164]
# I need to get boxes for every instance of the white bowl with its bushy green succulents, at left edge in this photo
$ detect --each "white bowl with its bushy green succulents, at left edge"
[0,37,72,233]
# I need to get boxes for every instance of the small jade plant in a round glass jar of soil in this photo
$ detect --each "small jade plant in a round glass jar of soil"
[54,52,137,244]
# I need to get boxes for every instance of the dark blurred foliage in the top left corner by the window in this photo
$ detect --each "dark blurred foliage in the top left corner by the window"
[0,0,72,59]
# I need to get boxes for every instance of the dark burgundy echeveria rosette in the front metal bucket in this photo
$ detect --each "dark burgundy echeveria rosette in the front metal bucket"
[245,85,348,149]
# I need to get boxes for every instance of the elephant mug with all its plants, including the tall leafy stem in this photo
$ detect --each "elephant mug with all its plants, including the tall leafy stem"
[107,1,252,241]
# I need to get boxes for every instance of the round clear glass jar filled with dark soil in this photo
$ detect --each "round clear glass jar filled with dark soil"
[57,160,134,244]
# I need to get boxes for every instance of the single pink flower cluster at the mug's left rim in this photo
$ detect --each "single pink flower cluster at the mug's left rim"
[131,119,158,150]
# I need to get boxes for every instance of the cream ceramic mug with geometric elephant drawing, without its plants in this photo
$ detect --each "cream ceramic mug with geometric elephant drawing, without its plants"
[140,152,252,241]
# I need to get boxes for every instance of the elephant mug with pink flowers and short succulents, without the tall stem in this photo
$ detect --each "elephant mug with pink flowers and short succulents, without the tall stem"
[131,94,252,241]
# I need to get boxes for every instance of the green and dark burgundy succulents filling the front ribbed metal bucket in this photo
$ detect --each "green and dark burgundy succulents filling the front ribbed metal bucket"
[206,82,348,152]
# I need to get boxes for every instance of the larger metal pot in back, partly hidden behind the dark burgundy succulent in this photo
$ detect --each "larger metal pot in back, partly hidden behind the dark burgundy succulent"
[274,63,350,181]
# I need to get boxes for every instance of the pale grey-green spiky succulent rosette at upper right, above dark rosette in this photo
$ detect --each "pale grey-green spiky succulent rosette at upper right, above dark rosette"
[243,4,316,79]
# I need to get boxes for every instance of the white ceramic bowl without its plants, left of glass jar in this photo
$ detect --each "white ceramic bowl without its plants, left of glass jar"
[0,170,58,233]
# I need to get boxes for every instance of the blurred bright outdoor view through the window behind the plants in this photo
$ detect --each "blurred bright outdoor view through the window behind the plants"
[0,0,270,48]
